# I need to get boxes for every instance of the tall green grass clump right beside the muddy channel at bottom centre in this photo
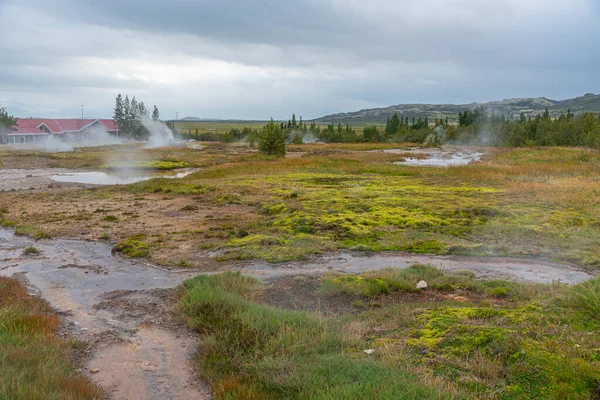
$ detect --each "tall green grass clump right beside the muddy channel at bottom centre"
[180,272,452,399]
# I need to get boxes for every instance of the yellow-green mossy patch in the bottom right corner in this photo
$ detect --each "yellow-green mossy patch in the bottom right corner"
[400,296,600,399]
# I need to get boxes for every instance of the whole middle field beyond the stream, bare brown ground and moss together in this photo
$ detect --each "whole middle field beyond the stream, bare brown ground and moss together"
[0,144,600,267]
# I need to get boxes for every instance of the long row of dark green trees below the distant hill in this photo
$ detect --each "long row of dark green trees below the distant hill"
[182,107,600,148]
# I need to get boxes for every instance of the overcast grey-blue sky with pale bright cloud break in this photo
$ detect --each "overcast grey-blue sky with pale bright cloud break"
[0,0,600,119]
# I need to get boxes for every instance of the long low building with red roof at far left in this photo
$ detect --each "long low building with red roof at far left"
[0,118,119,143]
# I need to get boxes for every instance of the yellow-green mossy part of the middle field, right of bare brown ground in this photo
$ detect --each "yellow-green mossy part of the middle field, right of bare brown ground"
[129,145,600,266]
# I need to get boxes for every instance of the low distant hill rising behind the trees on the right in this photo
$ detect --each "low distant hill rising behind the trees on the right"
[315,93,600,125]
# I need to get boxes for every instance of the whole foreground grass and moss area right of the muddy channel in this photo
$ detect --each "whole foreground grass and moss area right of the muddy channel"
[180,265,600,399]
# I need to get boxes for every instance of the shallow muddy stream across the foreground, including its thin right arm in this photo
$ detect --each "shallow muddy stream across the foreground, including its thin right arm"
[0,228,592,400]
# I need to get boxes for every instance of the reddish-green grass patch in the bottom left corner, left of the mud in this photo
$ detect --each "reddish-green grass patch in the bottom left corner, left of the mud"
[0,276,104,400]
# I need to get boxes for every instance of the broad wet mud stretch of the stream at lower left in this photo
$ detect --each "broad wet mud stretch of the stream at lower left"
[0,230,210,400]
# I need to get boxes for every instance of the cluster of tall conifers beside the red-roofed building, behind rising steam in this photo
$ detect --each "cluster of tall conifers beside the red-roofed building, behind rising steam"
[113,93,160,140]
